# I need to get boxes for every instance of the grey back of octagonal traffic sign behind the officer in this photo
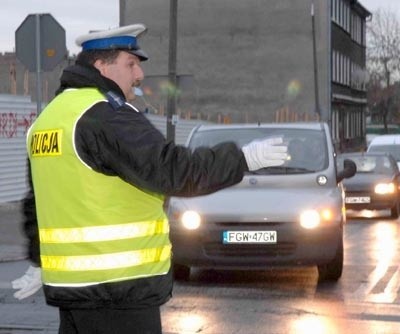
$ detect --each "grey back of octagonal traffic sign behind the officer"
[15,14,67,72]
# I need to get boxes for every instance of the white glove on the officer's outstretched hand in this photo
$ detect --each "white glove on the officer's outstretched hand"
[242,137,288,171]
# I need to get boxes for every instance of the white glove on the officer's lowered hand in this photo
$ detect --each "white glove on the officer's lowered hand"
[11,266,42,300]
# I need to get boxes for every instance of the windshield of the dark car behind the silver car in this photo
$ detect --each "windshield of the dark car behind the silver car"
[338,156,393,175]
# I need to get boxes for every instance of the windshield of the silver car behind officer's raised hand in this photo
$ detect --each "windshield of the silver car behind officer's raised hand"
[189,127,328,174]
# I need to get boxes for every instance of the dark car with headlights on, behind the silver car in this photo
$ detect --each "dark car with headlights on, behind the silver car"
[337,152,400,219]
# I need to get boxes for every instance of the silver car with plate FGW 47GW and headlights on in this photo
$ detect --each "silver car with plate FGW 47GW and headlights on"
[167,123,356,281]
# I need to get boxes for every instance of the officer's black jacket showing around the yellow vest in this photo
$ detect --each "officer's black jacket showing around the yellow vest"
[24,64,248,308]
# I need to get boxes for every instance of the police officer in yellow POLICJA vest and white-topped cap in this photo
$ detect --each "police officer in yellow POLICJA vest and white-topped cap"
[13,24,287,334]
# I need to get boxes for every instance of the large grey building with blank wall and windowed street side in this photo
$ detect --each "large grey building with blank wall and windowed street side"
[120,0,370,151]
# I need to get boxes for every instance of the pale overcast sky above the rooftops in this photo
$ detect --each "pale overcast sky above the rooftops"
[0,0,400,54]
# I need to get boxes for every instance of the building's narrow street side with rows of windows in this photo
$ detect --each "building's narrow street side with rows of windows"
[330,0,371,151]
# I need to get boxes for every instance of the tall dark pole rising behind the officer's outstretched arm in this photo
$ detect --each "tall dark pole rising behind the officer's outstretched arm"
[167,0,178,141]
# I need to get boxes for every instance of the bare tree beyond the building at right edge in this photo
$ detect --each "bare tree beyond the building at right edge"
[367,9,400,132]
